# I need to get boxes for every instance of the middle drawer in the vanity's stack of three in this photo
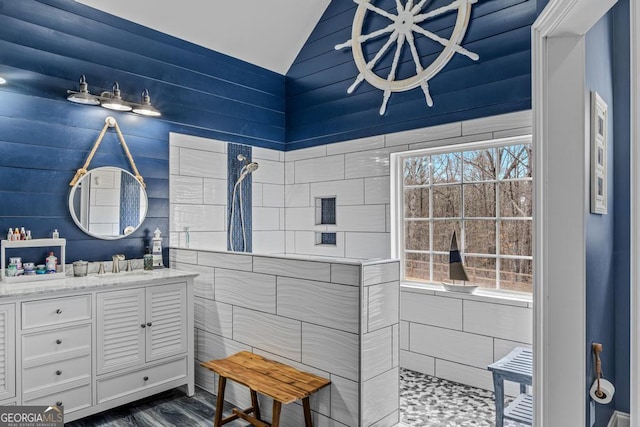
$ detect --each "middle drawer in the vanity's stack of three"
[22,325,91,363]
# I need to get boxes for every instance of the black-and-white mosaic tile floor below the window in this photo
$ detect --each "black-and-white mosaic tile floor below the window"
[400,369,522,427]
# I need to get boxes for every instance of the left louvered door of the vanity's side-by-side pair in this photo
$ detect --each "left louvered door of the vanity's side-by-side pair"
[97,288,147,375]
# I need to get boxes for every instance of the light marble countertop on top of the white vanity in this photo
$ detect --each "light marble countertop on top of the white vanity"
[0,268,198,299]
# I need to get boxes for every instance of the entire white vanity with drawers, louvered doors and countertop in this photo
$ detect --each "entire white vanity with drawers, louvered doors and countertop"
[0,269,196,422]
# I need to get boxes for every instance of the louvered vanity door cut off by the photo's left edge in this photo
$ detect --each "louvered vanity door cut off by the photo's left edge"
[0,304,16,400]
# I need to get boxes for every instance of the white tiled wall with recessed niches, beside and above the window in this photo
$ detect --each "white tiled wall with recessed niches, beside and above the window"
[285,111,532,259]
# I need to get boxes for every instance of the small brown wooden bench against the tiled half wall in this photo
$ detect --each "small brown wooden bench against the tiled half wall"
[201,351,331,427]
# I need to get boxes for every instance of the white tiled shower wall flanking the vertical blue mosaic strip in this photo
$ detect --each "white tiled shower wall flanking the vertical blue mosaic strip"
[169,133,285,253]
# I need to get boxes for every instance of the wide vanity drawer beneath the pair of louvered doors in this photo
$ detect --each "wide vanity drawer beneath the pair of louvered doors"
[98,358,187,404]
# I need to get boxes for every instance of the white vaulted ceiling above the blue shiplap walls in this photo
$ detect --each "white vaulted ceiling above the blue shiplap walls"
[76,0,330,75]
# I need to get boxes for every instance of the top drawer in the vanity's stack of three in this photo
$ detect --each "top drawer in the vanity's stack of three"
[22,295,91,329]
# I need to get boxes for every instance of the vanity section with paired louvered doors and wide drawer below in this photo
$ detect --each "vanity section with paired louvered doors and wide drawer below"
[97,283,189,404]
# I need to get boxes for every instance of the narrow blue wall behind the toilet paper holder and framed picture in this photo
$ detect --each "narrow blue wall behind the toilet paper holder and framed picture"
[585,0,630,427]
